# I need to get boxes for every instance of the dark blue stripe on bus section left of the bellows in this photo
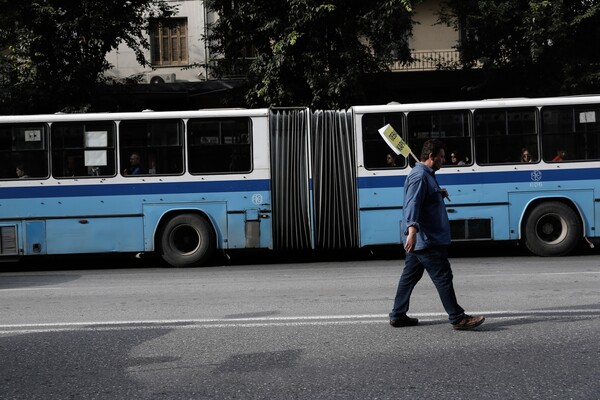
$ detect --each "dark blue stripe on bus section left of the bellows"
[0,179,270,199]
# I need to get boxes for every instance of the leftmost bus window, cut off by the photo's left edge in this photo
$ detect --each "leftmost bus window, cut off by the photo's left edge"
[0,124,48,179]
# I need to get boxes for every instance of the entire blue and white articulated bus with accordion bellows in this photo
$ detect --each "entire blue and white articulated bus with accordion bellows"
[0,96,600,267]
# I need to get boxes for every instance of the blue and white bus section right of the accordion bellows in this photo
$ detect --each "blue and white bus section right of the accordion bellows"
[353,96,600,256]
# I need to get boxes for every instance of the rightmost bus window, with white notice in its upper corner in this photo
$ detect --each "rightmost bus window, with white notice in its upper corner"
[542,104,600,162]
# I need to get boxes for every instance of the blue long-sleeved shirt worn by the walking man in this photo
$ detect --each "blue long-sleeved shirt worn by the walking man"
[401,163,450,250]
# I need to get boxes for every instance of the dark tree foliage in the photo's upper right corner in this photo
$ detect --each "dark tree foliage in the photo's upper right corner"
[440,0,600,95]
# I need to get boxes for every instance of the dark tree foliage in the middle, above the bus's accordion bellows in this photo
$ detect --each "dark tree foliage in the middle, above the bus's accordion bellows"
[205,0,412,108]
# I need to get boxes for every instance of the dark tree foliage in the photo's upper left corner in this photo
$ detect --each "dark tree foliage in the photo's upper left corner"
[0,0,176,113]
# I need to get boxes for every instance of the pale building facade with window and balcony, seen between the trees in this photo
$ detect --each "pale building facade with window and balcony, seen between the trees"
[106,0,476,108]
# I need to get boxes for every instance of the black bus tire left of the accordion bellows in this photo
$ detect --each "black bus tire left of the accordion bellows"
[158,214,215,267]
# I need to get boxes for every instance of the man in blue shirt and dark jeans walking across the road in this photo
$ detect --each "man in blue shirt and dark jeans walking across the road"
[390,139,485,330]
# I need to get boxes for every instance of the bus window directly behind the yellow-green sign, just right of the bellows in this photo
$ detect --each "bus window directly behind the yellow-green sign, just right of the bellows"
[362,112,406,169]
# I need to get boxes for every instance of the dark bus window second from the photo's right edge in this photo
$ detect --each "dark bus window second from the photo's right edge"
[474,107,539,165]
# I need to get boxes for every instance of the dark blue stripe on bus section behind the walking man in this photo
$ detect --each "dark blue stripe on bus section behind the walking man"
[358,168,600,189]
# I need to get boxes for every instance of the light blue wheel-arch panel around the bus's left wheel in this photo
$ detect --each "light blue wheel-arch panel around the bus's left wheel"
[143,201,227,251]
